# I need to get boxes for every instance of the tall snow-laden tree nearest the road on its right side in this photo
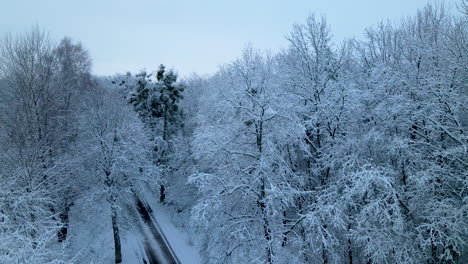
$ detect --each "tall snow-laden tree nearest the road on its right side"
[190,47,301,263]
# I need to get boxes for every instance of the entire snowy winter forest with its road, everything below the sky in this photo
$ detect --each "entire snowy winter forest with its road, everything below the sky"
[0,1,468,264]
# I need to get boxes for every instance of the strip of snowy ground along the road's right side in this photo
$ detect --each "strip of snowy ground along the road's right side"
[146,195,202,264]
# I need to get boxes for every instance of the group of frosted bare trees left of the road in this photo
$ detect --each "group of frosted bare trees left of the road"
[0,28,159,263]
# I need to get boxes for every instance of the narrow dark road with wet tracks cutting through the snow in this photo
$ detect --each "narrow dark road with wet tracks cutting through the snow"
[137,199,180,264]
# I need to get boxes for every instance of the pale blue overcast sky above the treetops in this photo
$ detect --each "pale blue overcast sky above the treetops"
[0,0,455,76]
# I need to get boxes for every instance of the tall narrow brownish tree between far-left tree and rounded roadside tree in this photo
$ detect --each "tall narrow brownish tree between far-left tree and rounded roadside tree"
[53,37,96,241]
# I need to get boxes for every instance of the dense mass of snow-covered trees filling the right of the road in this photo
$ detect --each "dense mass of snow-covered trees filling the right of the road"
[184,5,468,263]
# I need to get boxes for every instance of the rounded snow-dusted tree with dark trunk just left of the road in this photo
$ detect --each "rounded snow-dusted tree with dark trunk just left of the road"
[79,88,158,263]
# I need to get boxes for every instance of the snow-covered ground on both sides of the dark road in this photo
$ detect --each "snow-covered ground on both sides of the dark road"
[66,193,201,264]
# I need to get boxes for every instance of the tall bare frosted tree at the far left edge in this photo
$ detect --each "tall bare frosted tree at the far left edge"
[0,27,59,262]
